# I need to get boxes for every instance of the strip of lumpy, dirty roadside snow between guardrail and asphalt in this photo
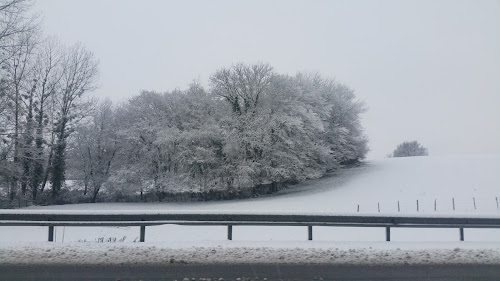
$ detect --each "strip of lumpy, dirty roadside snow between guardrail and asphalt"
[0,241,500,265]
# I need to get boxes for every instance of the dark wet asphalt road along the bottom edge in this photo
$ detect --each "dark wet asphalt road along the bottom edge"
[0,261,500,281]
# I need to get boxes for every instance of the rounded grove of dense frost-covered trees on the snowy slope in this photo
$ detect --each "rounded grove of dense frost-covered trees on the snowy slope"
[83,64,368,200]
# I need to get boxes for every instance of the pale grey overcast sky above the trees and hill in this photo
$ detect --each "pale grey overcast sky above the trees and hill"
[35,0,500,158]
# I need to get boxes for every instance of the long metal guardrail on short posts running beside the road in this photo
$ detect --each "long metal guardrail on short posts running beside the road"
[0,211,500,242]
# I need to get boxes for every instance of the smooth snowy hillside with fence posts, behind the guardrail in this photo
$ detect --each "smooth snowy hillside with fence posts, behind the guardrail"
[25,152,500,214]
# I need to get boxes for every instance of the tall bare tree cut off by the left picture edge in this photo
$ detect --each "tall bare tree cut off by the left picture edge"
[0,0,39,205]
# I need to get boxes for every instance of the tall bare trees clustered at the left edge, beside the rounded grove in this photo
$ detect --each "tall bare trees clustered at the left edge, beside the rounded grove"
[0,0,98,206]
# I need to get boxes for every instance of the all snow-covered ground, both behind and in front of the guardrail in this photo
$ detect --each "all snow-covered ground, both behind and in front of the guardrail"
[0,155,500,264]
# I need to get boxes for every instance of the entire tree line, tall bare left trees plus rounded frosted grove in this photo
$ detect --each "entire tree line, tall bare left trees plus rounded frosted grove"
[0,0,368,206]
